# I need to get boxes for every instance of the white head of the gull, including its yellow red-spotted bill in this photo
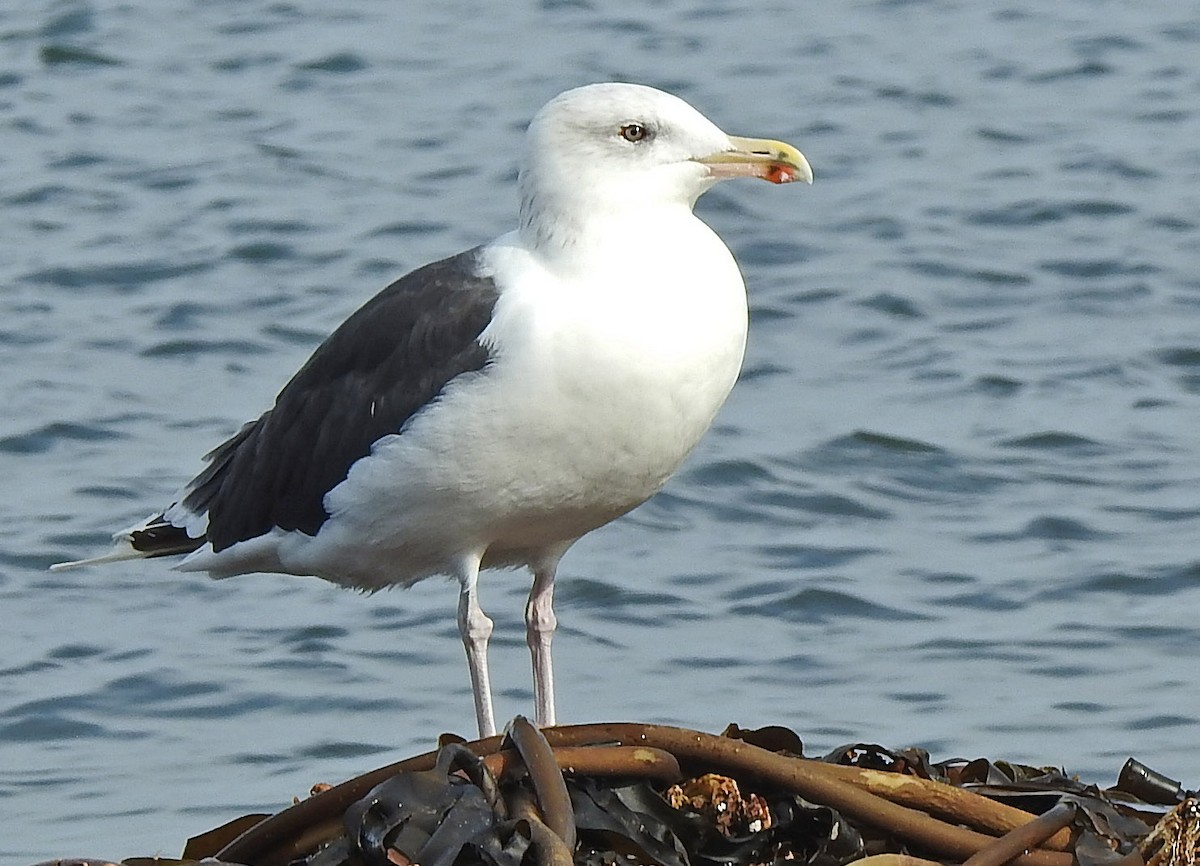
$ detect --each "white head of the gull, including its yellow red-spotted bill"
[518,84,812,254]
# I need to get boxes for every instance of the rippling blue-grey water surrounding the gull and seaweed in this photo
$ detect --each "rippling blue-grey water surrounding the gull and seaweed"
[0,0,1200,864]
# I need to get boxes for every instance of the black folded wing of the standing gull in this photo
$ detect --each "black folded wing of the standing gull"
[132,248,498,555]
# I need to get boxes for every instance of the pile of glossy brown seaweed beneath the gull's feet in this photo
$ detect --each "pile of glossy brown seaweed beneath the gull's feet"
[32,717,1200,866]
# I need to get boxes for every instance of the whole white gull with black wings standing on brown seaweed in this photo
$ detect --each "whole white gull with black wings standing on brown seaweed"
[55,84,812,736]
